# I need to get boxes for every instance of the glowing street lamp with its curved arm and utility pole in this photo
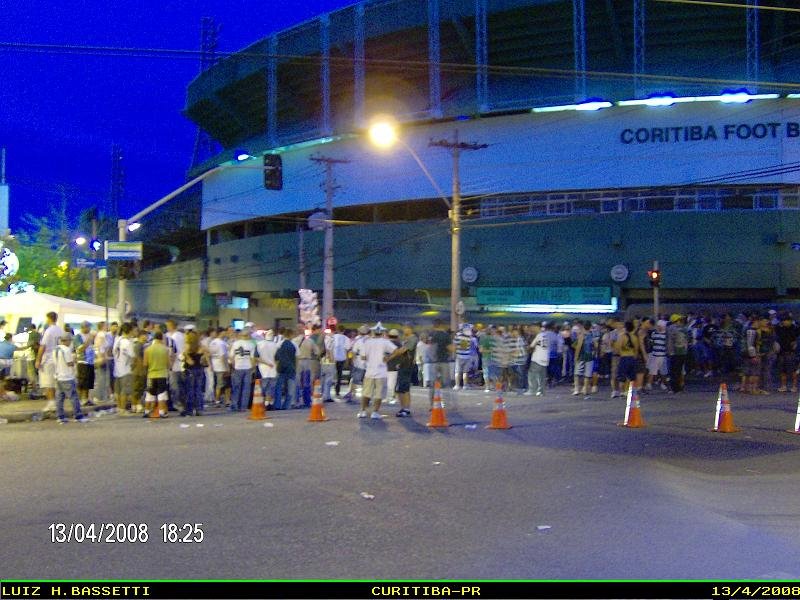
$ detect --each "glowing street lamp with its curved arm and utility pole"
[368,118,486,332]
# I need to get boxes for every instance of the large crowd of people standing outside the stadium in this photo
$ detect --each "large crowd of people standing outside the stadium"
[6,310,800,423]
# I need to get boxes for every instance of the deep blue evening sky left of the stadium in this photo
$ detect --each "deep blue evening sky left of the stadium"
[0,0,352,229]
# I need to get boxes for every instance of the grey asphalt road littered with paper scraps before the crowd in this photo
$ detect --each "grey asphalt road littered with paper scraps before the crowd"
[0,385,800,579]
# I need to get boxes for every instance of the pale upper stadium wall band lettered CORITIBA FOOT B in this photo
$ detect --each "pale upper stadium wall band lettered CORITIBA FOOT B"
[201,99,800,229]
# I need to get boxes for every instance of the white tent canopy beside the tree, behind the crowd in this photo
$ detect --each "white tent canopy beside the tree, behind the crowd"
[0,292,118,333]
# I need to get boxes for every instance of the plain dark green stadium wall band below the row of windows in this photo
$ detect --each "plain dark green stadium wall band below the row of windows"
[208,210,800,300]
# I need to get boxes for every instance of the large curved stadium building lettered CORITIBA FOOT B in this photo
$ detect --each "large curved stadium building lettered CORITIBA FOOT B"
[131,0,800,328]
